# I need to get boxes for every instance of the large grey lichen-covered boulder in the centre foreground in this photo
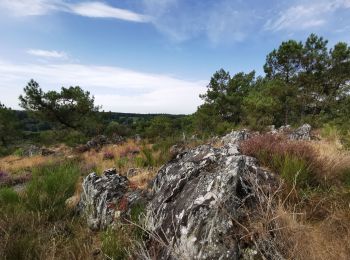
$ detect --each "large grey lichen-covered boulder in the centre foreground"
[146,130,272,259]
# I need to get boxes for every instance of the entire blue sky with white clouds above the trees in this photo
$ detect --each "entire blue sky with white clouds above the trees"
[0,0,350,114]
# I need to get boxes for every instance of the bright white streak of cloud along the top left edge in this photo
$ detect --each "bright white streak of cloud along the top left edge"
[0,0,150,22]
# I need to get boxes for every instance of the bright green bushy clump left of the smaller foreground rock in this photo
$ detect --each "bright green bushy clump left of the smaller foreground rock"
[25,162,80,219]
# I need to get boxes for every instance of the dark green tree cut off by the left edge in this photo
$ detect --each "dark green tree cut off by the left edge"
[0,103,21,147]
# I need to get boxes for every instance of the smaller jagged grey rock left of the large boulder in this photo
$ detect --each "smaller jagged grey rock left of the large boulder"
[77,169,129,230]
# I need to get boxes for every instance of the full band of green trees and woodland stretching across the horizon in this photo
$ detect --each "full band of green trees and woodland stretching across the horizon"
[0,34,350,153]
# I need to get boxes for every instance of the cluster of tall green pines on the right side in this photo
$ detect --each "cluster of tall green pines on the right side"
[194,34,350,132]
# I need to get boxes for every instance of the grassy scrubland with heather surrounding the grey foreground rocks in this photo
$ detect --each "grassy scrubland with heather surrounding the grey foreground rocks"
[0,131,350,259]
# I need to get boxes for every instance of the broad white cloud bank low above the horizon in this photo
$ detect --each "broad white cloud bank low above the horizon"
[0,61,207,114]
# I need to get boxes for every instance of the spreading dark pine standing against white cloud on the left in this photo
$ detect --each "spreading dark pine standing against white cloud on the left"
[19,79,99,132]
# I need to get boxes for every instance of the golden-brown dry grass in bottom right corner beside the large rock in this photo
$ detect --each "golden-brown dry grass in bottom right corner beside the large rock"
[235,179,350,260]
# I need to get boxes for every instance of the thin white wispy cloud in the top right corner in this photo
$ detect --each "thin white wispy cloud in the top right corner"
[264,0,350,32]
